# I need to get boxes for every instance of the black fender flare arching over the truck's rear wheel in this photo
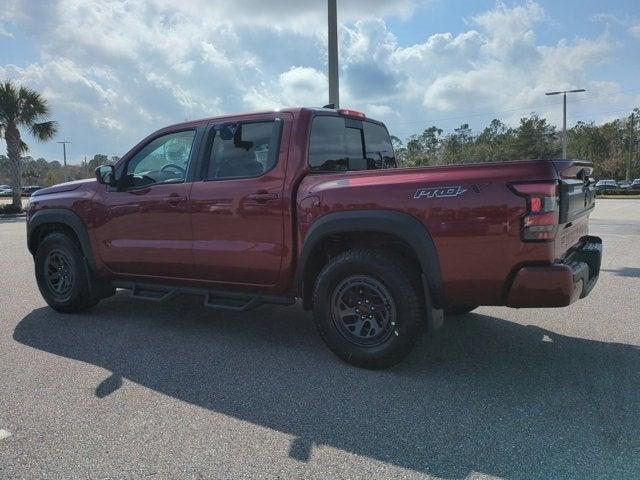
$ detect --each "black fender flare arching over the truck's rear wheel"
[295,210,444,307]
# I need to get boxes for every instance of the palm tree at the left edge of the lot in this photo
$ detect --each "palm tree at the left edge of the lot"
[0,81,57,208]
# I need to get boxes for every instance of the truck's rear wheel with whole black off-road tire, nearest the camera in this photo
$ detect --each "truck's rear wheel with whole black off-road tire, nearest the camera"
[313,249,425,369]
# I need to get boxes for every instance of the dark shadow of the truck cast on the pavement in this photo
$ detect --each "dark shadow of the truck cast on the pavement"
[14,293,640,479]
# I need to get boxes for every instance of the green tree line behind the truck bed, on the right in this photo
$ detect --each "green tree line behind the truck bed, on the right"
[392,108,640,179]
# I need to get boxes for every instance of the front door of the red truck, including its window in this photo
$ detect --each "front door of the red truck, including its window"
[94,129,197,278]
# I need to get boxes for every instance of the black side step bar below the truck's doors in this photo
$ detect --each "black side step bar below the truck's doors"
[113,282,295,312]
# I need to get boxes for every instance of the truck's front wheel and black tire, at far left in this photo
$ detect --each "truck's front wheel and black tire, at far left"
[35,232,100,313]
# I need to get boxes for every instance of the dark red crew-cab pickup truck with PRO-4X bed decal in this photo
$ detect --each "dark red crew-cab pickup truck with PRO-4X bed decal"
[27,108,602,368]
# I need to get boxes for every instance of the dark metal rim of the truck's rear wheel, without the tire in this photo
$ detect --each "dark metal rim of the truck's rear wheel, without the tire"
[331,275,397,347]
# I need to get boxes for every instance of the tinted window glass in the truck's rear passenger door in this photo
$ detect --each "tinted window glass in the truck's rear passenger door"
[205,120,281,180]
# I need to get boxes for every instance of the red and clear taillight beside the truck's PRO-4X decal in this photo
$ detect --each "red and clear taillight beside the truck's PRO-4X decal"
[511,182,559,241]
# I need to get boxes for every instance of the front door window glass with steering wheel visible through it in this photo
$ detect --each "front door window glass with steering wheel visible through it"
[123,130,196,187]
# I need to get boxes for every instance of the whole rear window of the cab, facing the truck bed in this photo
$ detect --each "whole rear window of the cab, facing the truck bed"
[309,115,396,172]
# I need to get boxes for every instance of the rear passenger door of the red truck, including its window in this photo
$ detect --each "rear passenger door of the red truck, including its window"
[190,113,292,286]
